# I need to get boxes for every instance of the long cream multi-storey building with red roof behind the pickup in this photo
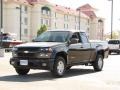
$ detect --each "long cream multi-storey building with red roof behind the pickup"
[4,0,104,41]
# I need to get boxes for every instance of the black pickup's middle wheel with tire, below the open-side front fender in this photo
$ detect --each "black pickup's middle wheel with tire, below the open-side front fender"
[51,56,66,77]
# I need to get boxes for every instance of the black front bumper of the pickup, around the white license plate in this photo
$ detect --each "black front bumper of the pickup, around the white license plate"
[10,58,54,70]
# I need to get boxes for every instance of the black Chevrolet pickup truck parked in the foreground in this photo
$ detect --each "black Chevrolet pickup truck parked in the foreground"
[10,30,106,77]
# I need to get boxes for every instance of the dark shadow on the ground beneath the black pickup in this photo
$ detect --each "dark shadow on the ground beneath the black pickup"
[0,69,96,82]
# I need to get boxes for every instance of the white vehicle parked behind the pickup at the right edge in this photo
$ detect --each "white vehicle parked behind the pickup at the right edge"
[108,39,120,54]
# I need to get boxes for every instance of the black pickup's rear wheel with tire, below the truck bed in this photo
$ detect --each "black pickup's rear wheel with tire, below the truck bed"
[93,55,104,71]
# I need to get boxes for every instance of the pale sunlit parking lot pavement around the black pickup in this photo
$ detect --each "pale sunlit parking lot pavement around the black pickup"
[0,53,120,90]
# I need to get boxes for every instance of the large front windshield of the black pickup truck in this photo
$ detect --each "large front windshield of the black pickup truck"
[34,31,69,42]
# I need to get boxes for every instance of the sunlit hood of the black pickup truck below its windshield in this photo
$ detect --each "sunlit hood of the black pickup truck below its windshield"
[16,42,63,47]
